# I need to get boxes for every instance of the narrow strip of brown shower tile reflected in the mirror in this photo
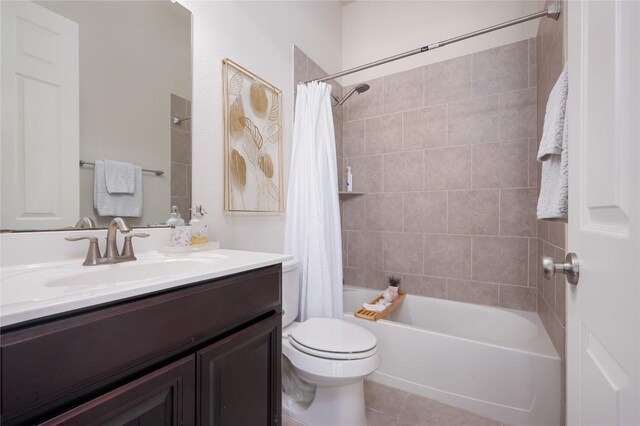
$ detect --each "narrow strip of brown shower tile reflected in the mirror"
[167,94,191,222]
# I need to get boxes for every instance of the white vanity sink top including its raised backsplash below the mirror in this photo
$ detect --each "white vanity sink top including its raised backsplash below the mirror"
[0,229,291,327]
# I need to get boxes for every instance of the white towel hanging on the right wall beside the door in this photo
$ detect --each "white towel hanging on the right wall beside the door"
[538,65,569,222]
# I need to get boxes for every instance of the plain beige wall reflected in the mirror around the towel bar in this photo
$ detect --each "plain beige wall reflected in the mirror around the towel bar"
[38,1,191,225]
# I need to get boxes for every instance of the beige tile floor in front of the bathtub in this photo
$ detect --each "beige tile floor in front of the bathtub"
[282,380,505,426]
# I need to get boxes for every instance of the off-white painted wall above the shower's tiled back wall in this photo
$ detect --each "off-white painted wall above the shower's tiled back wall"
[342,1,542,86]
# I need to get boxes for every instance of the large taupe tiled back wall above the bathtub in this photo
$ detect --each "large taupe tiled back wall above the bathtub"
[340,39,538,311]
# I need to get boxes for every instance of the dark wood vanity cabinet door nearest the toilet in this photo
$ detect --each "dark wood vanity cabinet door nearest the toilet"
[197,313,282,426]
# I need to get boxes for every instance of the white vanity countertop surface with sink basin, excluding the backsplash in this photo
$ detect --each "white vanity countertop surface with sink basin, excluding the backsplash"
[0,249,292,327]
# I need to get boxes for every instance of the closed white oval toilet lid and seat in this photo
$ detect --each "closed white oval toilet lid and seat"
[289,318,377,359]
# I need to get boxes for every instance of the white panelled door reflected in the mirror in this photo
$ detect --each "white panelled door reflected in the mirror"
[0,1,79,229]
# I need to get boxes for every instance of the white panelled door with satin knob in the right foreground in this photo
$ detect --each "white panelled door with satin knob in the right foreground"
[566,1,640,425]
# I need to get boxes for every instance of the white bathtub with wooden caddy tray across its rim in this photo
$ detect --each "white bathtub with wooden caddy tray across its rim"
[344,286,561,426]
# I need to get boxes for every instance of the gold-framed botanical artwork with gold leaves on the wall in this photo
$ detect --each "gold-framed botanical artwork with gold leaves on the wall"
[222,59,284,212]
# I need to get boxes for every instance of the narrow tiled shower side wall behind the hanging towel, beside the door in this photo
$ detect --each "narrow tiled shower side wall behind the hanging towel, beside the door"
[536,2,566,423]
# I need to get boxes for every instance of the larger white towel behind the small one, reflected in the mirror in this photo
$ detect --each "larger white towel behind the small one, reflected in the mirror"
[93,160,142,217]
